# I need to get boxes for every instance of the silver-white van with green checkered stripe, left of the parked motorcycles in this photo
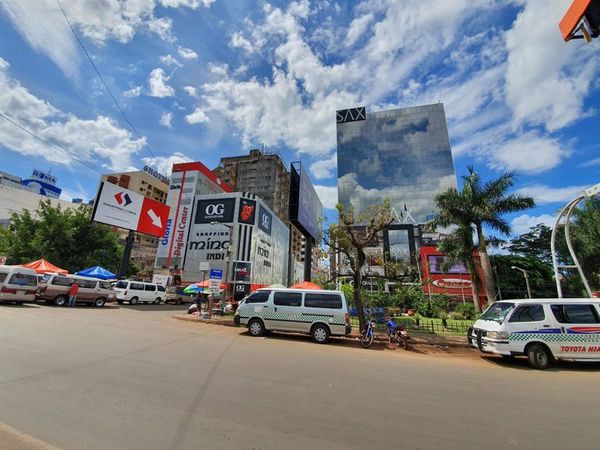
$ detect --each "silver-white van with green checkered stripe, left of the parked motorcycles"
[234,288,351,344]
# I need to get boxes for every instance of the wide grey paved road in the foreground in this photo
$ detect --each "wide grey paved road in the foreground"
[0,305,600,449]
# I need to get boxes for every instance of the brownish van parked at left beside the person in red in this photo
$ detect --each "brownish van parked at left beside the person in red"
[37,274,115,308]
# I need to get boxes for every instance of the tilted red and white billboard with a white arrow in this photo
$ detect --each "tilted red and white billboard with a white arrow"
[92,183,170,237]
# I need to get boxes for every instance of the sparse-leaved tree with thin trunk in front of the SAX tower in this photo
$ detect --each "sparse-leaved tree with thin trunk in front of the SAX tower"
[324,200,394,330]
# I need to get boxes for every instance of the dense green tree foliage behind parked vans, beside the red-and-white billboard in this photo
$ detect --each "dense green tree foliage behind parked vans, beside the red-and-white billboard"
[0,201,130,273]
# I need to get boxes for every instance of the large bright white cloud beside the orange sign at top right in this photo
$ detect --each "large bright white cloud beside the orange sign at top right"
[506,0,600,131]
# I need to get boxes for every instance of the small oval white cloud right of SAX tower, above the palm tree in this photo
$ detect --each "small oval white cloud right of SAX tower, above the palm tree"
[488,132,570,173]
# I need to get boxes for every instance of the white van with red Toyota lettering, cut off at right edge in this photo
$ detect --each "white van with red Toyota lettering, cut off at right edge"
[468,298,600,369]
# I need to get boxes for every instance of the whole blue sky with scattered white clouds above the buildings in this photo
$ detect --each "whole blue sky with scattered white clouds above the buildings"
[0,0,600,237]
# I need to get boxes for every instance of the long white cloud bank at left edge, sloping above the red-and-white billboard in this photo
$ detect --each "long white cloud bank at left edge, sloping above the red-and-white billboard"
[0,58,145,170]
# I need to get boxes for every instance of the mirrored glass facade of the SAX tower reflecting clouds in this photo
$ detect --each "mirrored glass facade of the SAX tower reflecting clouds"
[337,103,456,225]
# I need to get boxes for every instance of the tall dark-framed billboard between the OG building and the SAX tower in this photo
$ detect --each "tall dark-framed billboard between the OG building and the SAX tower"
[290,163,323,240]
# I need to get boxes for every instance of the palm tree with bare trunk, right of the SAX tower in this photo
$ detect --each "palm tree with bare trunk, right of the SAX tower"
[429,166,535,302]
